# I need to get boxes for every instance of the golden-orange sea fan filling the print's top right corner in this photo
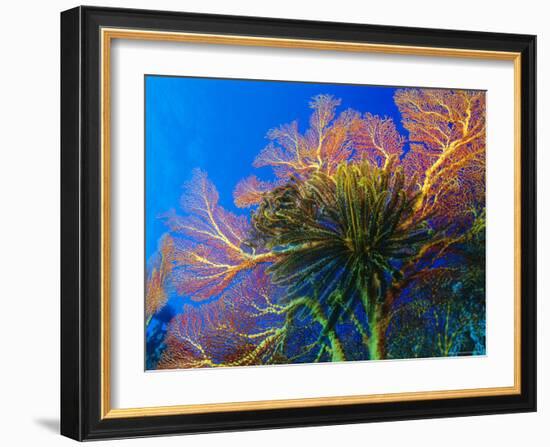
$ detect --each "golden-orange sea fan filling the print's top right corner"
[395,89,486,224]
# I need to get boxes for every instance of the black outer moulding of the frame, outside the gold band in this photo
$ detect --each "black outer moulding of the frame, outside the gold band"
[61,6,536,440]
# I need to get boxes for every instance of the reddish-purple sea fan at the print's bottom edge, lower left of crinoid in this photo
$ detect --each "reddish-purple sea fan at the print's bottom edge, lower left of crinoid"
[159,267,285,369]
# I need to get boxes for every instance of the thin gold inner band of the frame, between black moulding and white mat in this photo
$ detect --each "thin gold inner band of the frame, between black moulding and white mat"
[100,28,521,419]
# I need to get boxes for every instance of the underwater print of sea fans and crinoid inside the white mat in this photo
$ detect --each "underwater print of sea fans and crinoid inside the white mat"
[144,75,486,370]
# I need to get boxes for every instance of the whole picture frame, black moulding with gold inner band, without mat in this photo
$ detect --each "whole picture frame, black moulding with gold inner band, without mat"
[61,6,537,441]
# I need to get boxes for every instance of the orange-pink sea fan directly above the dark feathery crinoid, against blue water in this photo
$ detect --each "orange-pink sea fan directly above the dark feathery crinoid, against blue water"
[234,94,405,208]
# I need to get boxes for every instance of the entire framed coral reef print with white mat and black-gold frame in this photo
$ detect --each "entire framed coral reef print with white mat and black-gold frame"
[61,7,536,440]
